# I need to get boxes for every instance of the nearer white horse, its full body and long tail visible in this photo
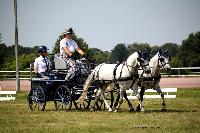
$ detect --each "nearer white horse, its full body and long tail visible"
[77,52,150,111]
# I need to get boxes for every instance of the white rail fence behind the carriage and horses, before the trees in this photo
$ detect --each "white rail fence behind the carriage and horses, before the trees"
[0,67,200,80]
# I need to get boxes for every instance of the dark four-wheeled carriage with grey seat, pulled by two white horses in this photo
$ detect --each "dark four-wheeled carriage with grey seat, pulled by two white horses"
[27,54,113,111]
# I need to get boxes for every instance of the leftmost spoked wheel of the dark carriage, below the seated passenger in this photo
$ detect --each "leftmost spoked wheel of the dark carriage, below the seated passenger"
[28,86,46,111]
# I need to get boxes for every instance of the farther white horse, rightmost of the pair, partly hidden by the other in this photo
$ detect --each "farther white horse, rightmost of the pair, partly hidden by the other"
[136,50,171,111]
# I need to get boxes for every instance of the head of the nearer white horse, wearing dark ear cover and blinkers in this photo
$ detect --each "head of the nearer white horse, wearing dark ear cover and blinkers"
[137,51,151,74]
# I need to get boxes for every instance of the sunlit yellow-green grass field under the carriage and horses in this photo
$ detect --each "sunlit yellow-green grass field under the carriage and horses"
[0,88,200,133]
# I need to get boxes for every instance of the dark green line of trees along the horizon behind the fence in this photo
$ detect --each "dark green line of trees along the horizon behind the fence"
[0,32,200,70]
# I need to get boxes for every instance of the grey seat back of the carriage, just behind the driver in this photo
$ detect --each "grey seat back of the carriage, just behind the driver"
[54,54,69,70]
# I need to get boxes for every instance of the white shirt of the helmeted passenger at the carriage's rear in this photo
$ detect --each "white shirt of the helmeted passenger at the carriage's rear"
[34,55,50,73]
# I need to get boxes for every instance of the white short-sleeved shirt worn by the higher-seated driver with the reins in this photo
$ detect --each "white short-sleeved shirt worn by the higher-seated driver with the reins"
[60,38,78,56]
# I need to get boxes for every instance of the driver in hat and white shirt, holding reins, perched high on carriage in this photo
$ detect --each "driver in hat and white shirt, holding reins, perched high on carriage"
[60,28,84,79]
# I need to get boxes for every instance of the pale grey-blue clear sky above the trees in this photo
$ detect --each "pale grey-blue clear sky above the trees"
[0,0,200,51]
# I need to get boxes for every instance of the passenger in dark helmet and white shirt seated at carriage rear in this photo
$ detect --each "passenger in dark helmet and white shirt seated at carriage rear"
[34,45,51,78]
